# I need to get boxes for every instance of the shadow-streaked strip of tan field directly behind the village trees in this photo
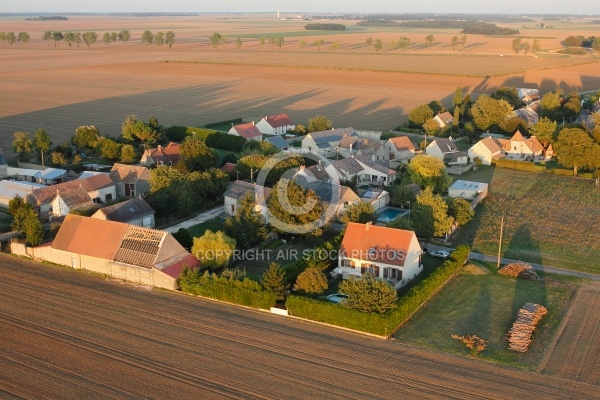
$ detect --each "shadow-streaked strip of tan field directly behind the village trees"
[0,81,404,157]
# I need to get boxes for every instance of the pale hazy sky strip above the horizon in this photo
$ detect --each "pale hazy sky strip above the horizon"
[0,0,599,14]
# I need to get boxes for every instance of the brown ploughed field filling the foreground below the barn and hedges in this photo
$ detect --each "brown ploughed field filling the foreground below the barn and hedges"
[0,255,599,399]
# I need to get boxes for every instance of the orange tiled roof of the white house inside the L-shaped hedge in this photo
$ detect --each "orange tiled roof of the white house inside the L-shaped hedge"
[340,222,417,267]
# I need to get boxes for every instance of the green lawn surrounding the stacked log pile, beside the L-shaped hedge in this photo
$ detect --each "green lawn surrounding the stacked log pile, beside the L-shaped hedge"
[394,263,577,369]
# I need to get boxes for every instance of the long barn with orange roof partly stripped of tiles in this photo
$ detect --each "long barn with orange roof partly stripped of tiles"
[13,215,198,290]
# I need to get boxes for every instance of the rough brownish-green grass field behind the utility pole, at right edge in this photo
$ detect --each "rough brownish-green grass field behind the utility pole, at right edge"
[453,166,600,273]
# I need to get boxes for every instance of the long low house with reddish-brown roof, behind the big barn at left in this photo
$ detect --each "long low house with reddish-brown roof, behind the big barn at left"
[27,174,117,218]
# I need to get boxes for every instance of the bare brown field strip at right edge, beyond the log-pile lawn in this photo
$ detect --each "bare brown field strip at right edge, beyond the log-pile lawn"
[543,283,600,385]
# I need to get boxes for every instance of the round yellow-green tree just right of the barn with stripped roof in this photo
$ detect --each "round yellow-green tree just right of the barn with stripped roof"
[192,230,235,270]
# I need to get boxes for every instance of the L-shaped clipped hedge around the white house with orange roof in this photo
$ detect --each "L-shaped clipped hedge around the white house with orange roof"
[286,246,471,337]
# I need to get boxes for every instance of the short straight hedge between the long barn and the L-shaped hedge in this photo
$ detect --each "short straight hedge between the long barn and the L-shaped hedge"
[178,268,277,310]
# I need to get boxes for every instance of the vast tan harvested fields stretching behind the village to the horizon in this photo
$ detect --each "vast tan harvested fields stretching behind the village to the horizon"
[0,15,600,159]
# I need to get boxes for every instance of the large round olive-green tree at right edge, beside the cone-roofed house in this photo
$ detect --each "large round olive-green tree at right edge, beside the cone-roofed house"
[553,128,600,175]
